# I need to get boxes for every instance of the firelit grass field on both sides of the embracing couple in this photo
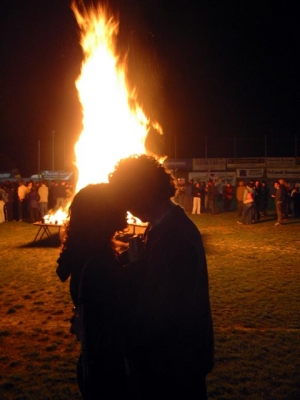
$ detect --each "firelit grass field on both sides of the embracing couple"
[0,212,300,400]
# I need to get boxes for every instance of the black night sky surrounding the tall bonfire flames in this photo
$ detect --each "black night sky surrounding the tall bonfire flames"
[0,0,300,176]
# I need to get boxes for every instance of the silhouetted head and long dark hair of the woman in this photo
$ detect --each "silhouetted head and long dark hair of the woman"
[57,183,126,281]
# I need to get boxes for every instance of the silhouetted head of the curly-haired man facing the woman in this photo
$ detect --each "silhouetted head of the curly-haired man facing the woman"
[109,154,176,220]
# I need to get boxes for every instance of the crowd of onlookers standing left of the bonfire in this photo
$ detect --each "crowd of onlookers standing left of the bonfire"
[0,179,73,223]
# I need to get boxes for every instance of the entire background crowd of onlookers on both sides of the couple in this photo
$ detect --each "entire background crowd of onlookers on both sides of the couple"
[0,179,300,226]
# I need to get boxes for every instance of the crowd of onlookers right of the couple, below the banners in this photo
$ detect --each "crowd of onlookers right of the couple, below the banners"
[174,179,300,226]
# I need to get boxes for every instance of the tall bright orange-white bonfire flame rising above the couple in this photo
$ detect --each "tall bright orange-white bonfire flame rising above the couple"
[71,2,157,192]
